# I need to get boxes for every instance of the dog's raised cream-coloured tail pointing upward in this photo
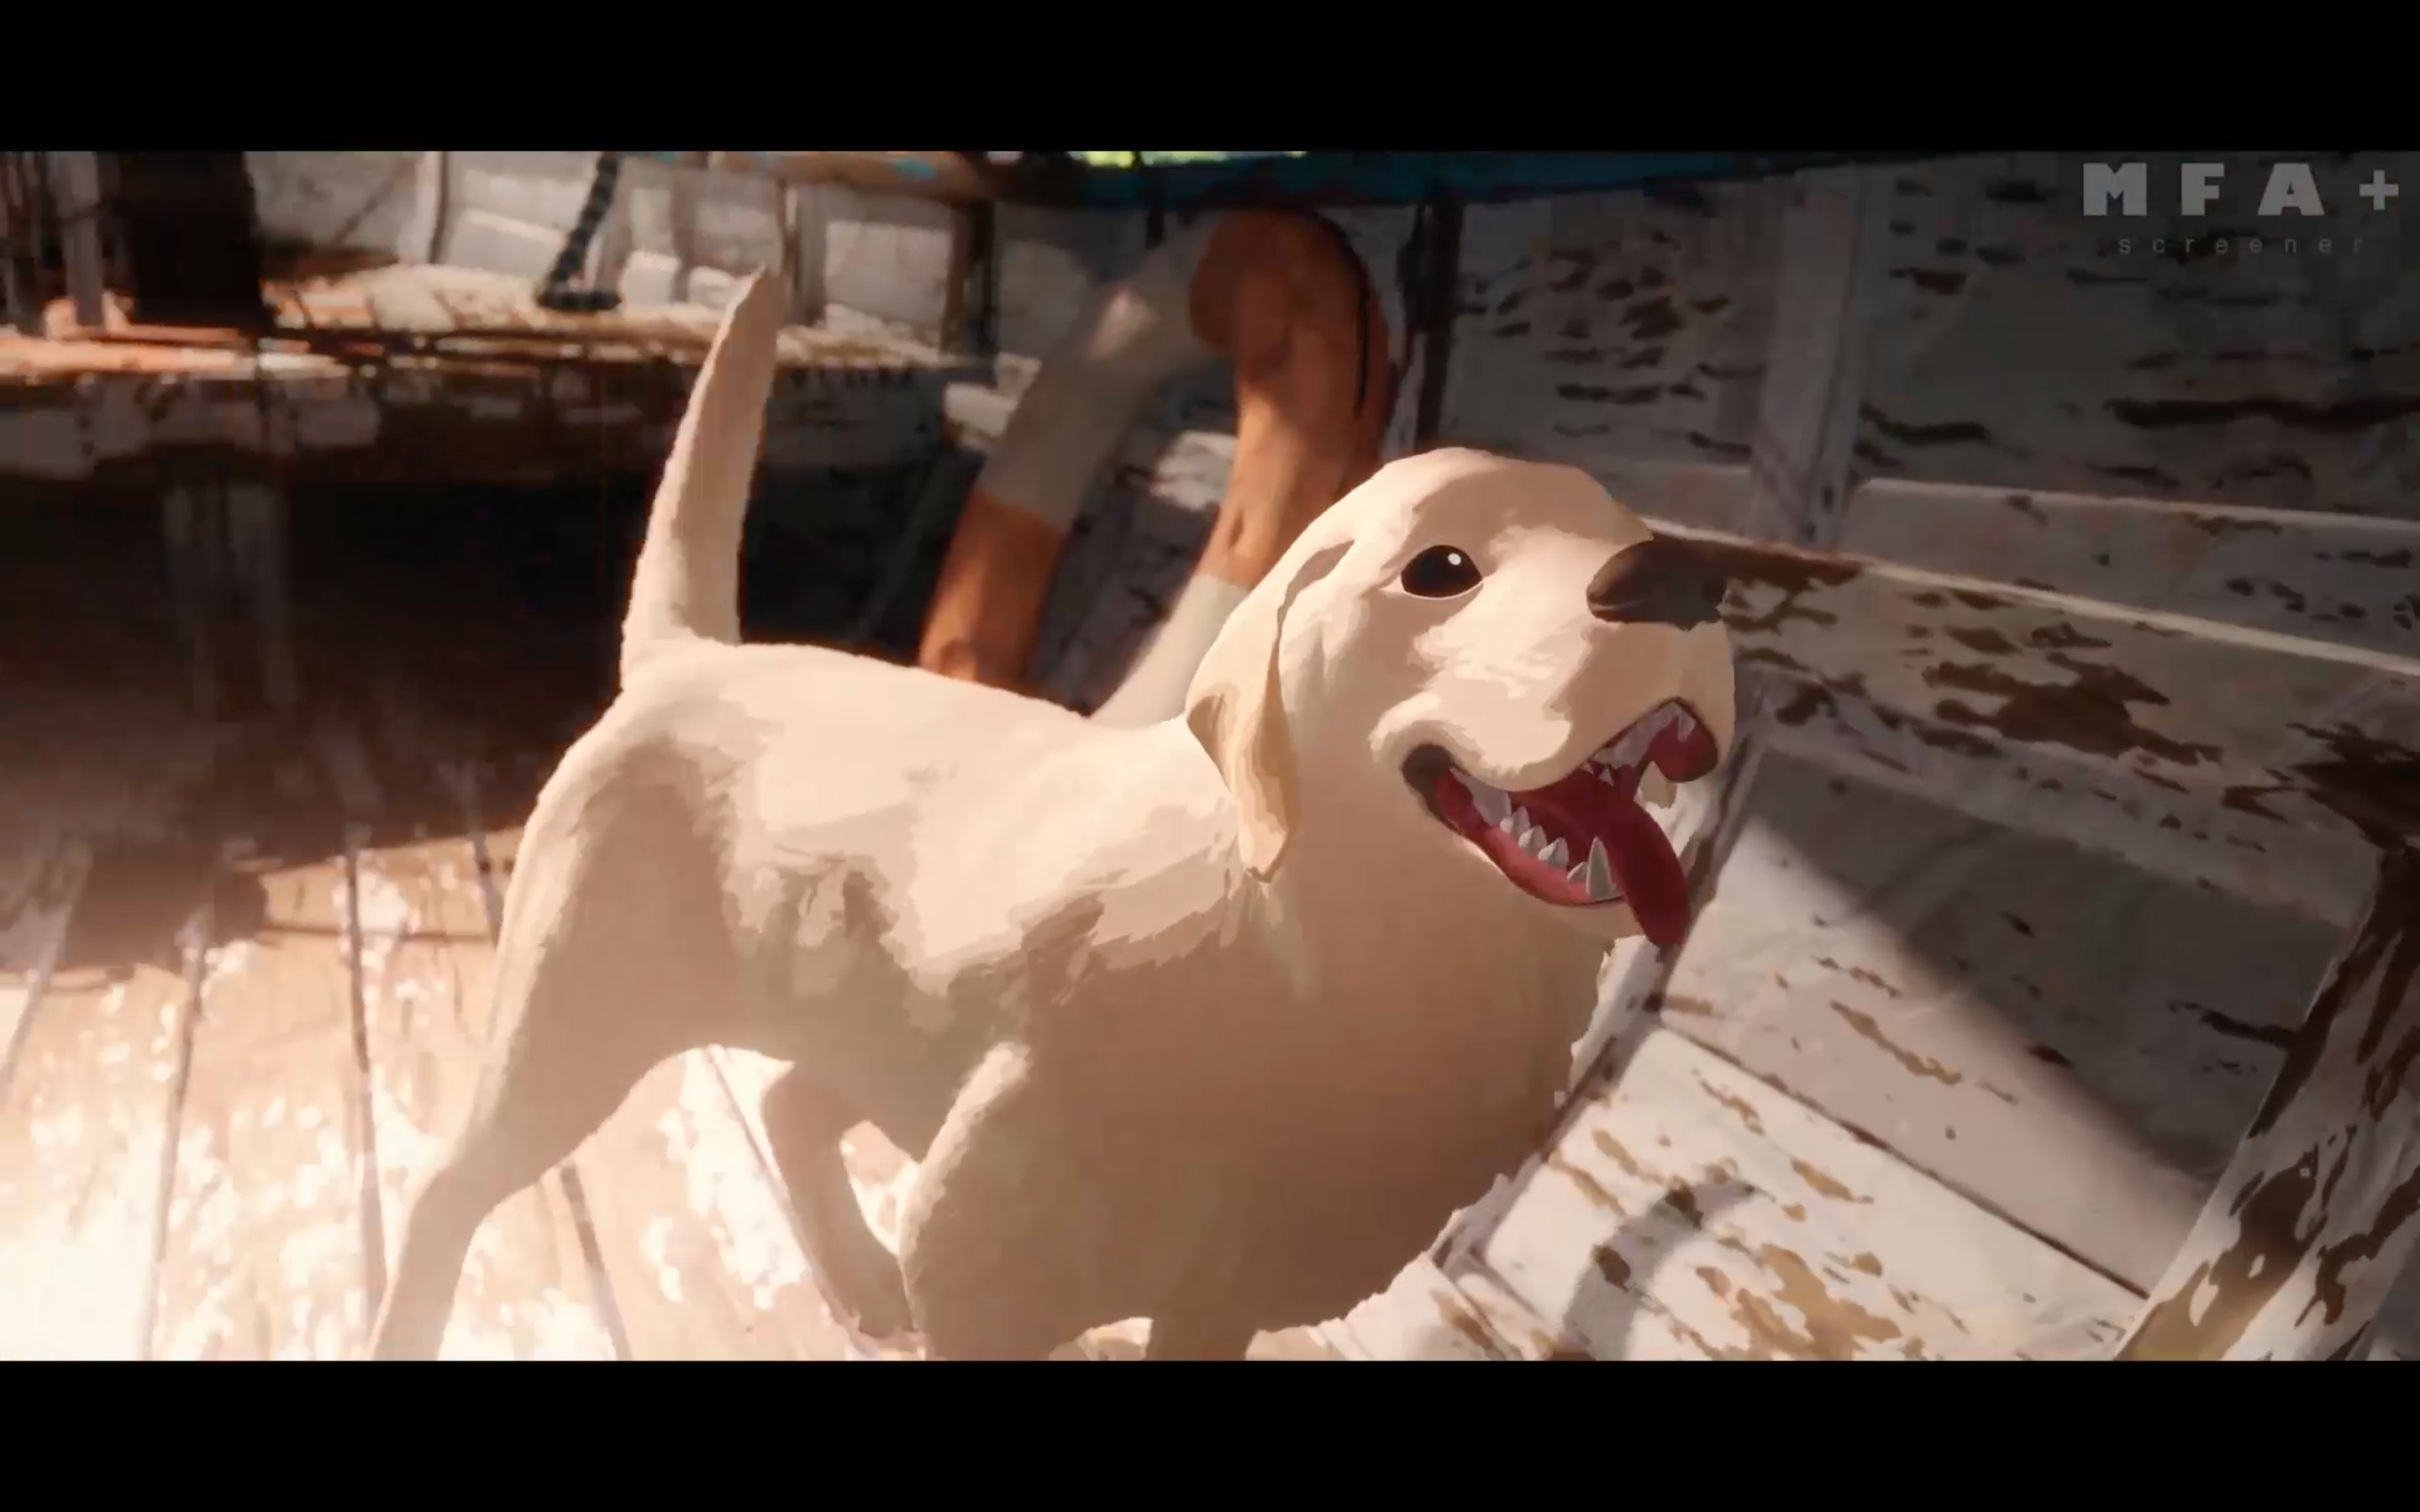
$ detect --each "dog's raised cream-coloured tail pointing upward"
[622,273,786,687]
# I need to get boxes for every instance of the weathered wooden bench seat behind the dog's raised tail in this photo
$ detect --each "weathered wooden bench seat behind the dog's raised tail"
[0,264,978,484]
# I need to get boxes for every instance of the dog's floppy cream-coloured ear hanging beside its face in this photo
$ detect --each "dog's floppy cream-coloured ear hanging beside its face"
[1186,537,1353,880]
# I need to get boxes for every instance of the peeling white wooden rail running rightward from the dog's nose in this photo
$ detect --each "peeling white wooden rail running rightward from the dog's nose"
[1667,525,2420,851]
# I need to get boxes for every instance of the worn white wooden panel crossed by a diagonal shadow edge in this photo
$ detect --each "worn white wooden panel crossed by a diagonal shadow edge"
[1663,755,2335,1289]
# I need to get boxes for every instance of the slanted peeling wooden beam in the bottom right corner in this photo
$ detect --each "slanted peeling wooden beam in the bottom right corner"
[2118,837,2420,1360]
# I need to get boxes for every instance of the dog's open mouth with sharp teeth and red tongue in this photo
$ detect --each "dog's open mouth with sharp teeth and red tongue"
[1403,701,1721,946]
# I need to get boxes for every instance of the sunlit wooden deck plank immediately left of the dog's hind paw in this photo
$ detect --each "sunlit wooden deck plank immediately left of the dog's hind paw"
[152,753,377,1360]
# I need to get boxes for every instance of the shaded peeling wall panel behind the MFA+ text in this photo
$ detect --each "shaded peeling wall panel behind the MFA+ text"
[1859,152,2420,520]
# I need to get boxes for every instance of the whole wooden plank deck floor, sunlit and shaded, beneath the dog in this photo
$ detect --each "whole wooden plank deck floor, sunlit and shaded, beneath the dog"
[0,493,1321,1360]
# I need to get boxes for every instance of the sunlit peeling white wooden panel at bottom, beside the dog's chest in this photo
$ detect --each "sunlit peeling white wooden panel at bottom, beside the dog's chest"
[1474,1028,2137,1360]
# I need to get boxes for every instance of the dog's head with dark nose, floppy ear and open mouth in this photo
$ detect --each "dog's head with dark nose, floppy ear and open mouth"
[1186,450,1733,943]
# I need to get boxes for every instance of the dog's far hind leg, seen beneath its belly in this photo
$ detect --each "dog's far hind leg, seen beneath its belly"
[765,1067,910,1341]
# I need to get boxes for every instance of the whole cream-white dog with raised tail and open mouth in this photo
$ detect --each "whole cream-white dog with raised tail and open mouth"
[375,268,1733,1357]
